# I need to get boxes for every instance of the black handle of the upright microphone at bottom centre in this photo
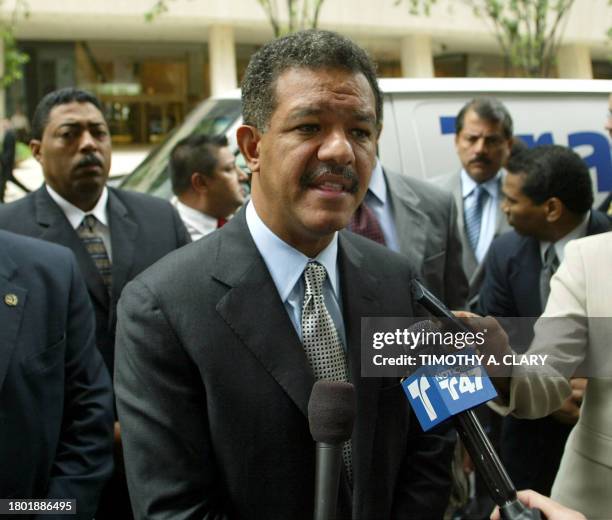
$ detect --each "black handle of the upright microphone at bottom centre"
[313,442,342,520]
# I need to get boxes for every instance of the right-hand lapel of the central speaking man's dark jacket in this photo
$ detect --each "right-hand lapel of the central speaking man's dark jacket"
[338,232,382,518]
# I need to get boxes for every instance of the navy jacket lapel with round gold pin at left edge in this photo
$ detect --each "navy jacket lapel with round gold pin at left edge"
[0,246,28,390]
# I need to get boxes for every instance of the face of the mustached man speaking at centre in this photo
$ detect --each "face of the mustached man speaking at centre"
[238,68,379,256]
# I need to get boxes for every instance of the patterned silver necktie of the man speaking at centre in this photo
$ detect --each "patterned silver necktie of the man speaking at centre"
[302,262,353,482]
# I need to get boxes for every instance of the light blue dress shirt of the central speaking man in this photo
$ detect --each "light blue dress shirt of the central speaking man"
[246,200,346,350]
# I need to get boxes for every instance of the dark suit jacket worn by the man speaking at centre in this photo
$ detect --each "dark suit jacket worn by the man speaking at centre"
[115,211,453,520]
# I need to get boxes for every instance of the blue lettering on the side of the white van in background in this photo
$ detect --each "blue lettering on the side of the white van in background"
[440,116,612,191]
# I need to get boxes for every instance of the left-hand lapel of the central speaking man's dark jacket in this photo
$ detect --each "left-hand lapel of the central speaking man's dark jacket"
[213,211,314,417]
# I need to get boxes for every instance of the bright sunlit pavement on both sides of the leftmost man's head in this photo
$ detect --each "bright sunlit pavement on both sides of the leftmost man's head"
[5,145,153,202]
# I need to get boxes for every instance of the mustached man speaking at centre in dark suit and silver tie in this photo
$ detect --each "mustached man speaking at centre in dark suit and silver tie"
[115,30,452,520]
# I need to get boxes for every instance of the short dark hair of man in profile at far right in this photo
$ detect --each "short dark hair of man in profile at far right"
[507,144,593,214]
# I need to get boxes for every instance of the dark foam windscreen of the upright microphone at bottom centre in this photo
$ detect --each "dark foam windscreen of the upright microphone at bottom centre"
[308,380,356,444]
